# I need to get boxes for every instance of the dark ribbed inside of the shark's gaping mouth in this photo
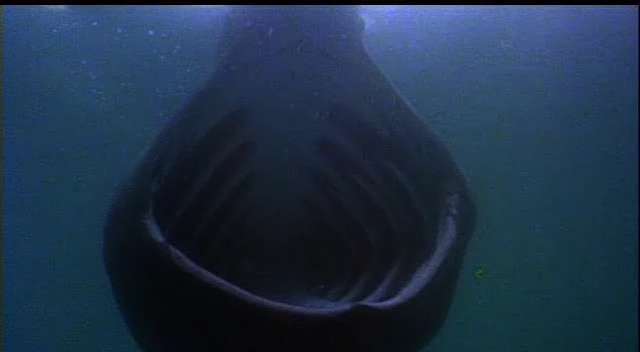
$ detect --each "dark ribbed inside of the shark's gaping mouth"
[149,107,448,308]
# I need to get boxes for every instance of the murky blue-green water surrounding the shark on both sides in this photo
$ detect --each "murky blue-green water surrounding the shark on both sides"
[2,6,638,352]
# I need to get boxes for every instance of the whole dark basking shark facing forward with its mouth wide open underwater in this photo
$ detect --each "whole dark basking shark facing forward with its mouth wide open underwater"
[104,6,475,352]
